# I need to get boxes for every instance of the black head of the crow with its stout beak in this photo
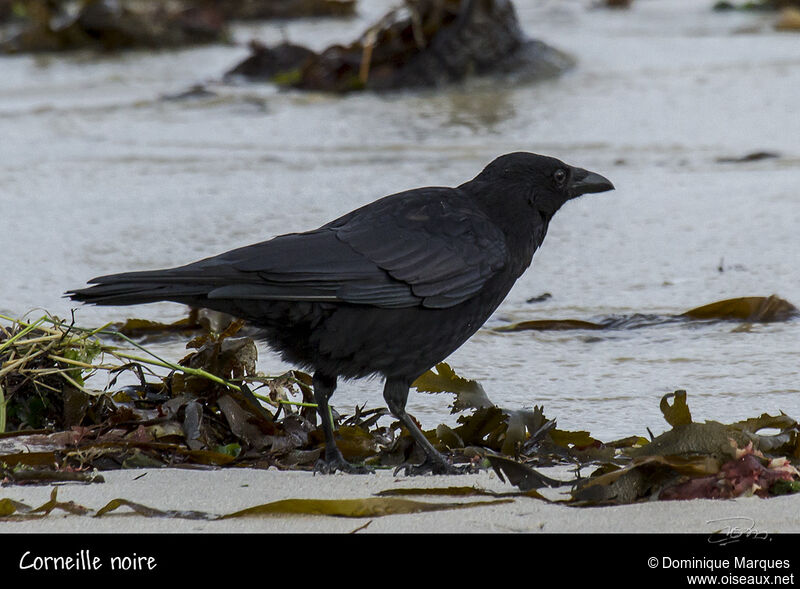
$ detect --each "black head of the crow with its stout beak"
[464,152,614,222]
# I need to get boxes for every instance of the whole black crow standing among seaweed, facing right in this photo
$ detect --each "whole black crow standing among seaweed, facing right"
[65,152,614,474]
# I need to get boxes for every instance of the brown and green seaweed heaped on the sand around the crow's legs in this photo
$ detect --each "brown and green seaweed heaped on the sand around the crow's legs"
[0,297,800,506]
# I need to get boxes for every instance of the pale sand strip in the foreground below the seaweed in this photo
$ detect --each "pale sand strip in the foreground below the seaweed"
[0,469,800,534]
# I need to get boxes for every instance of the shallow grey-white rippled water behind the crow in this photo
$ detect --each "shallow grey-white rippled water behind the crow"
[0,0,800,439]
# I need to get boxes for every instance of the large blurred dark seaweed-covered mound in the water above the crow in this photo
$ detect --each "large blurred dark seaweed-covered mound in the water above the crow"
[226,0,573,92]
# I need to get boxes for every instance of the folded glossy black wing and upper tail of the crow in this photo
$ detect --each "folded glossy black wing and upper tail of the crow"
[79,188,506,308]
